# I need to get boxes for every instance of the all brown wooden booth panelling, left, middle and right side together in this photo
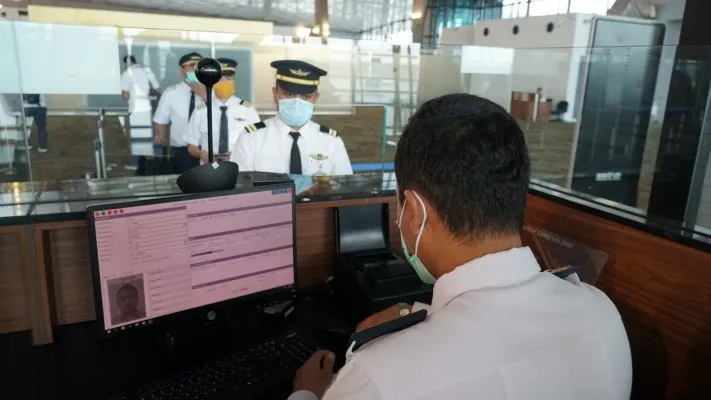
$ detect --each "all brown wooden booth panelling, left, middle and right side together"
[0,194,711,400]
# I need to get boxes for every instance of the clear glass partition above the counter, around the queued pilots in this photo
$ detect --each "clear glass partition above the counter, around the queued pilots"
[0,21,711,245]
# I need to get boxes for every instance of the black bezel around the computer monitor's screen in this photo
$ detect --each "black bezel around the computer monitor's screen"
[86,182,298,337]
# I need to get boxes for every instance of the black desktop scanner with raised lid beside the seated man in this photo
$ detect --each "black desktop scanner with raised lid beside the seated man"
[333,203,432,323]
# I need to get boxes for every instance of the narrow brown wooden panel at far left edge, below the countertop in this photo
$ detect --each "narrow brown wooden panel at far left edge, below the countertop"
[0,230,30,333]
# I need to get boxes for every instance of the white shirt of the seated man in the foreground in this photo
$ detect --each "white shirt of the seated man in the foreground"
[289,248,632,400]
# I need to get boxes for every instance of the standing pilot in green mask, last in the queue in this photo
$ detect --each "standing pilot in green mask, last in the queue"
[153,53,207,174]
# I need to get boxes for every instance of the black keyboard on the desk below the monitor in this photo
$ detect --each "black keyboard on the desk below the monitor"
[112,333,315,400]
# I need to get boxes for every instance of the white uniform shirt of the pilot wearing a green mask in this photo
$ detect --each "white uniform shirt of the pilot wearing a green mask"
[153,82,203,147]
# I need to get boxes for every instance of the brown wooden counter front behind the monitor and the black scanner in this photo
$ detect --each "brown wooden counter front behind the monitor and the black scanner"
[0,197,400,345]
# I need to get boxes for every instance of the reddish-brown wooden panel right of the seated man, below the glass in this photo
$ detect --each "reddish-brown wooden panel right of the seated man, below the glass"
[526,196,711,400]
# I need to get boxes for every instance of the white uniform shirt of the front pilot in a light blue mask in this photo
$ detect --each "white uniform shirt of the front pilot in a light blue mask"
[232,116,353,175]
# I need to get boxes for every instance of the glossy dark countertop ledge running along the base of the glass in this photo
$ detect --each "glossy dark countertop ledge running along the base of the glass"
[0,172,711,251]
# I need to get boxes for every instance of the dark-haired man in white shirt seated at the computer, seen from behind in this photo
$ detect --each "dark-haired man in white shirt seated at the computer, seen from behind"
[290,94,632,400]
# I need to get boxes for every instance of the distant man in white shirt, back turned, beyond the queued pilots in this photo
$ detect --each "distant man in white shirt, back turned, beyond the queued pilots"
[121,55,160,168]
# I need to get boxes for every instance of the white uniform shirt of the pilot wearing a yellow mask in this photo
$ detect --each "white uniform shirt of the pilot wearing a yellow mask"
[185,96,259,162]
